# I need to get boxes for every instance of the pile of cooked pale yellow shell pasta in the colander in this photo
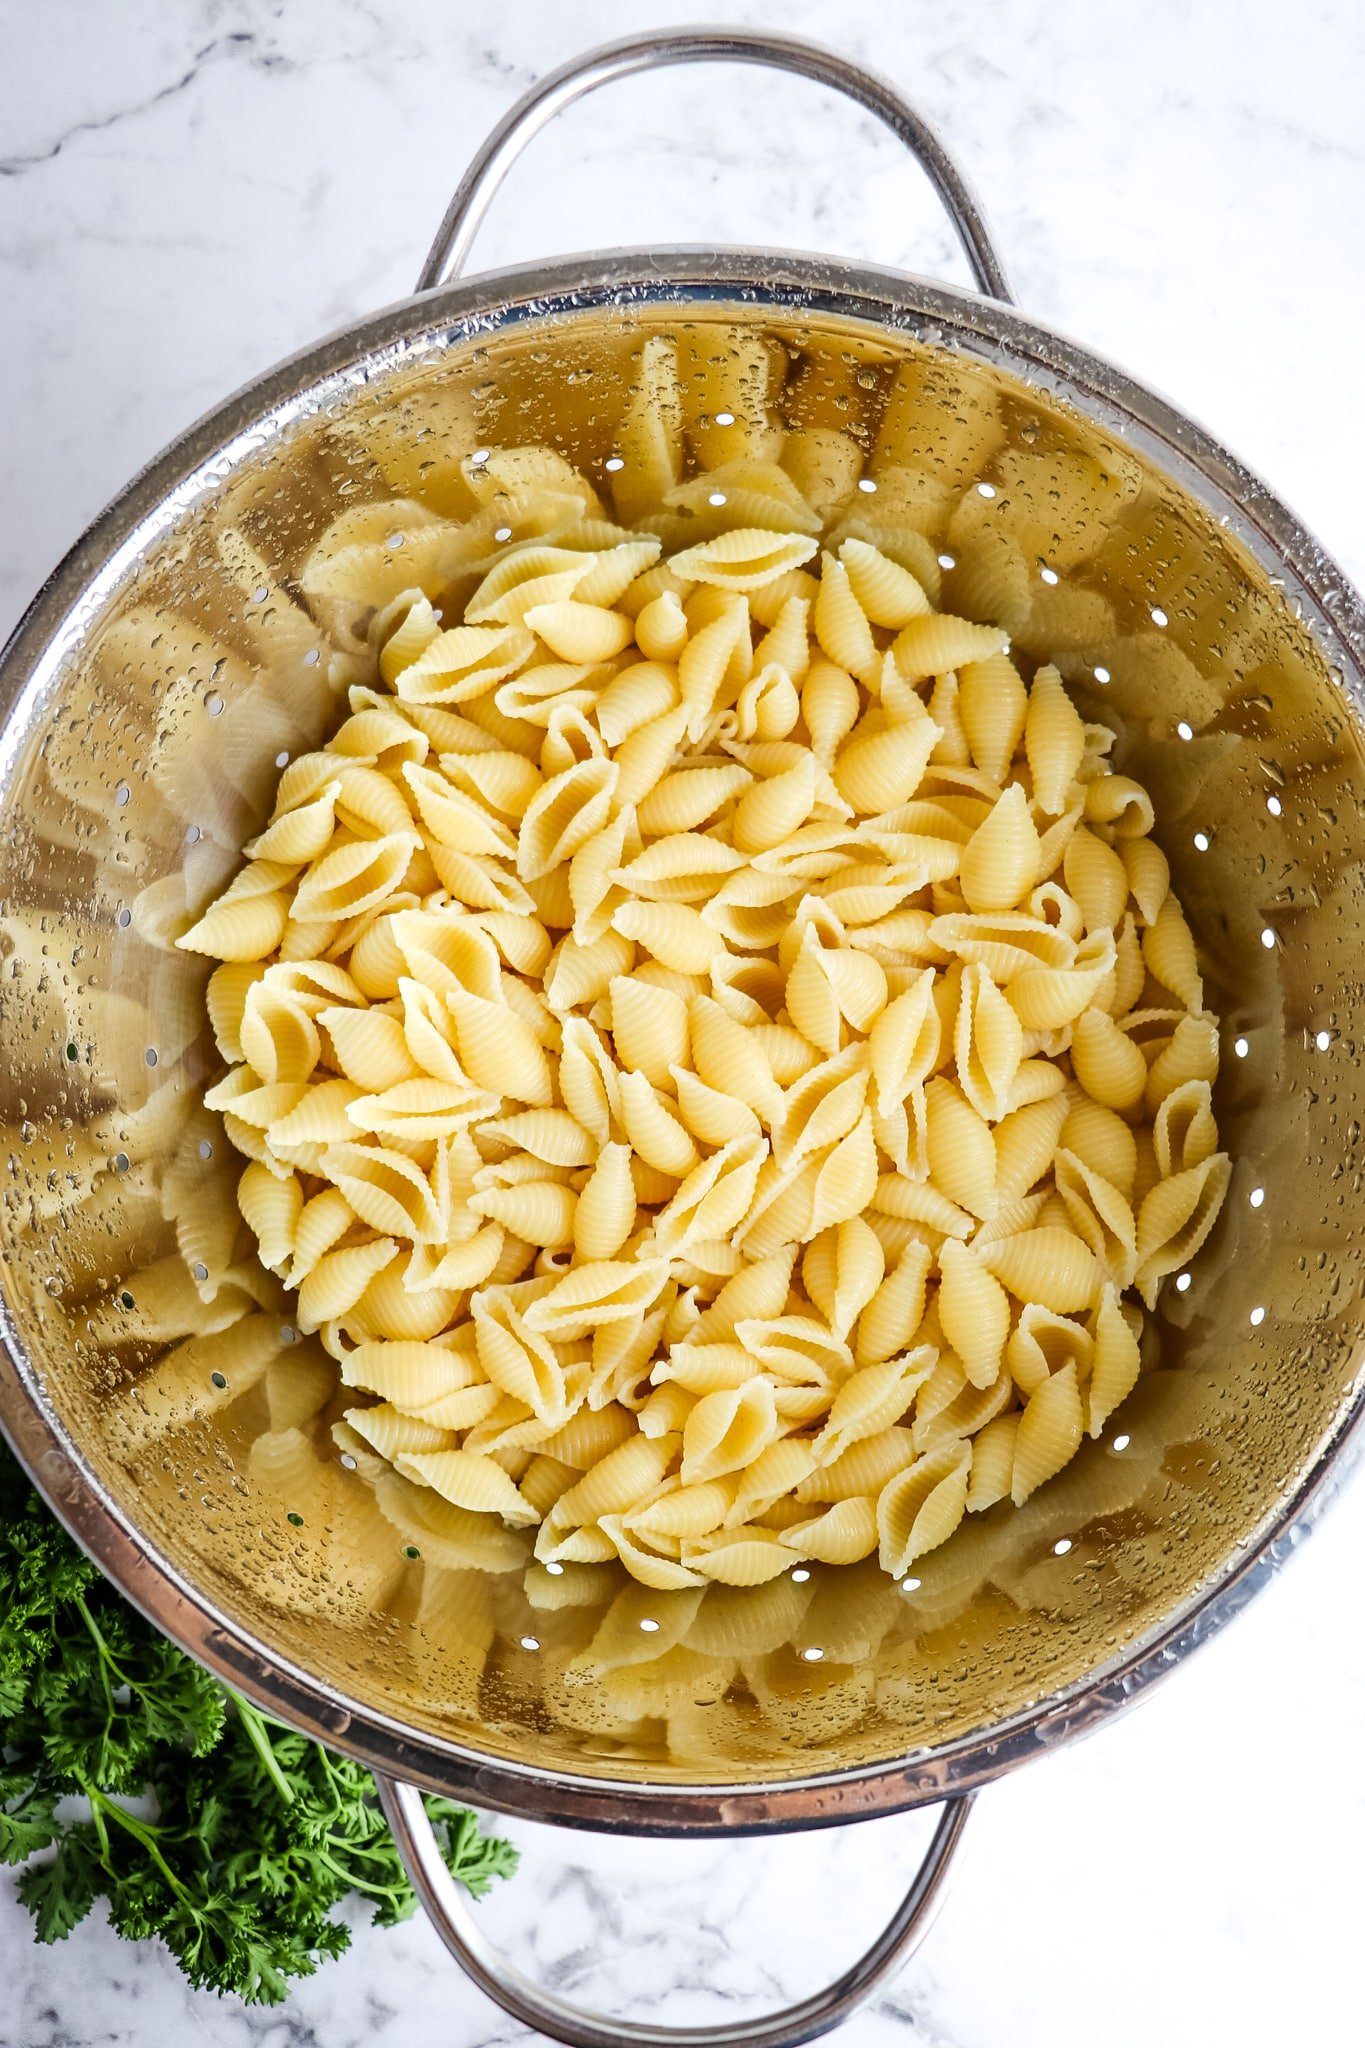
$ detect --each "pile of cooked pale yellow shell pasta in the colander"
[180,471,1230,1589]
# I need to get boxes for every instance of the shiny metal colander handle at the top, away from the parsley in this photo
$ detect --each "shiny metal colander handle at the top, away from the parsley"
[417,29,1013,305]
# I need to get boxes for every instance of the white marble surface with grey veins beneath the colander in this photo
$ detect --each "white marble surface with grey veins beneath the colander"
[0,0,1365,2048]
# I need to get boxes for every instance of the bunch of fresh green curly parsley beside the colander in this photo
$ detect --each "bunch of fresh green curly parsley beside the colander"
[0,1442,516,2003]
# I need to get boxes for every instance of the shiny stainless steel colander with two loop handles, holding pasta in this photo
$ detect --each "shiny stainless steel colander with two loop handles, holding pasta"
[0,31,1365,2048]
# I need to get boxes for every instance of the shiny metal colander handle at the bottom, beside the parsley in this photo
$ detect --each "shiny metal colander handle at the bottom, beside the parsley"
[377,1774,976,2048]
